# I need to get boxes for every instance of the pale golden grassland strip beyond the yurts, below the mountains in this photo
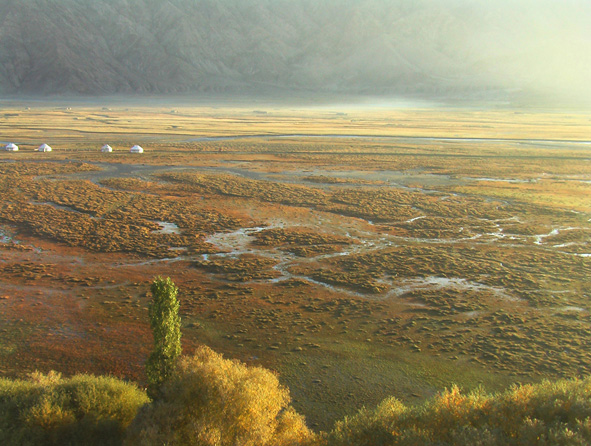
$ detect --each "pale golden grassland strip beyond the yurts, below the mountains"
[0,104,590,148]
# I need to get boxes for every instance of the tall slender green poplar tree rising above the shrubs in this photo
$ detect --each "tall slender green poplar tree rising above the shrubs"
[146,277,181,399]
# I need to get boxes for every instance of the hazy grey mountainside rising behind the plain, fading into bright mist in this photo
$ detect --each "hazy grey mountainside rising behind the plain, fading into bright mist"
[0,0,591,103]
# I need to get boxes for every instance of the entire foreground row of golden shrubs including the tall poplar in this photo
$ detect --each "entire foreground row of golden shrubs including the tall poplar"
[0,278,591,446]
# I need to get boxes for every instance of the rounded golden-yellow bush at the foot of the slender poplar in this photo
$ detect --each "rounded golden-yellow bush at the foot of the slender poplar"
[126,347,311,446]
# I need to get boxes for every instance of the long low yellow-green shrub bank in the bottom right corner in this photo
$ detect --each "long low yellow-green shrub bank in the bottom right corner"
[322,378,591,446]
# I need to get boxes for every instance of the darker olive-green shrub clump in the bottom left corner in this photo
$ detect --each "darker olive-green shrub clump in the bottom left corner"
[0,372,148,446]
